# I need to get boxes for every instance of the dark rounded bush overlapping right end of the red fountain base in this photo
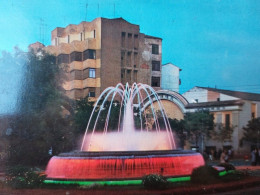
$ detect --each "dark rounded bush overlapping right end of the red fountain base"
[191,165,219,184]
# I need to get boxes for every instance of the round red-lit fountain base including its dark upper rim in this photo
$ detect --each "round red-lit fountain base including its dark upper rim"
[45,150,205,181]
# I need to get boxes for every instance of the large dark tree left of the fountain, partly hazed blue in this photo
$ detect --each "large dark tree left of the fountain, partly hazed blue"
[9,48,74,165]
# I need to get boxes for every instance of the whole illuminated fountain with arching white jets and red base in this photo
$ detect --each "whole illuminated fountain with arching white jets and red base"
[46,83,204,182]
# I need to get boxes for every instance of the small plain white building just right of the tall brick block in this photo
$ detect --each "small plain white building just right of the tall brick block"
[161,63,181,92]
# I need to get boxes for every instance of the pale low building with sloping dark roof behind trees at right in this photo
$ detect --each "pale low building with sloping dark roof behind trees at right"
[183,87,260,155]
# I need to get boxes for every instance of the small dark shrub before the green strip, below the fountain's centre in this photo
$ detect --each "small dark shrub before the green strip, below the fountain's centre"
[142,174,169,189]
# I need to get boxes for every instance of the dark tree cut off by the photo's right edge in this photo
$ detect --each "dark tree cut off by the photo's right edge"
[241,117,260,147]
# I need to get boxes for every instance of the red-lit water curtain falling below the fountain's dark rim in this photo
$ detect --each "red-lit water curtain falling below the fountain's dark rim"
[46,153,204,180]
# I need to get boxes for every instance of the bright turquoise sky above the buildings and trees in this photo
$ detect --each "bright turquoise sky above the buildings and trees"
[0,0,260,113]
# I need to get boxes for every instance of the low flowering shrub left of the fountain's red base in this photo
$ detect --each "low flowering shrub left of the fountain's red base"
[6,166,46,188]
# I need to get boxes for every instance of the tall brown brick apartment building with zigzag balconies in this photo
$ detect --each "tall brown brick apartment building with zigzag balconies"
[40,18,162,99]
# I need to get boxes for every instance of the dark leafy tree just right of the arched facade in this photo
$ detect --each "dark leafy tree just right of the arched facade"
[184,110,214,148]
